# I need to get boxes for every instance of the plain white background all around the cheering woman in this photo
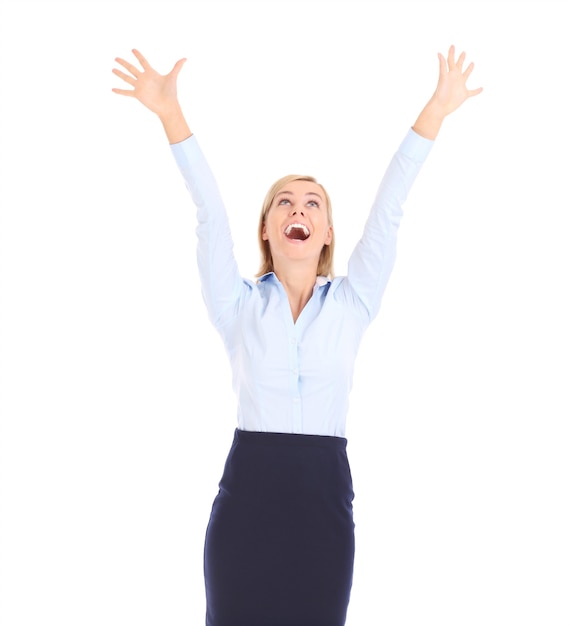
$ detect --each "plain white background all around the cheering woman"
[0,0,572,626]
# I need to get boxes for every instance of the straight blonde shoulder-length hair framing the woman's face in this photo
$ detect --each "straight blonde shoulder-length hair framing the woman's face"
[255,174,335,278]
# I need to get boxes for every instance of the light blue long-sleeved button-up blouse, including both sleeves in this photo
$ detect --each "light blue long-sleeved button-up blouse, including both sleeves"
[171,129,433,437]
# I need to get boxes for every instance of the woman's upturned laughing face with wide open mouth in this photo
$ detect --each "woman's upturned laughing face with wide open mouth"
[262,180,332,267]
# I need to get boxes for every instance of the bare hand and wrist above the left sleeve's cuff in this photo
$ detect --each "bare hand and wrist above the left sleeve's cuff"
[112,50,192,144]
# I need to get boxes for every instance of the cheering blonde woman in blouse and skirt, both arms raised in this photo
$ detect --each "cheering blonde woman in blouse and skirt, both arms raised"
[113,46,482,626]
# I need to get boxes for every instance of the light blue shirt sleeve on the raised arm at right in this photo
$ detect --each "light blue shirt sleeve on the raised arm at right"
[348,129,433,321]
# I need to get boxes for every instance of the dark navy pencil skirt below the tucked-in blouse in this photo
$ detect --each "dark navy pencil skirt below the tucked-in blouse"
[204,429,355,626]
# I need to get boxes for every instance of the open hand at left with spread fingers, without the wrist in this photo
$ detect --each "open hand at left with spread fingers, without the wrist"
[112,50,186,117]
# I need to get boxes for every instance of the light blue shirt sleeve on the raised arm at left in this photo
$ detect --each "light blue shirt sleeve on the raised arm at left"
[171,135,243,327]
